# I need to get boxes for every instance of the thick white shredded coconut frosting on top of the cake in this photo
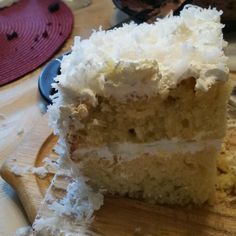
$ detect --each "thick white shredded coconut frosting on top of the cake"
[55,5,228,106]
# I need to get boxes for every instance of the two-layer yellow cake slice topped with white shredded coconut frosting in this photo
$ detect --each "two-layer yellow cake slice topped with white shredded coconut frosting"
[49,6,230,204]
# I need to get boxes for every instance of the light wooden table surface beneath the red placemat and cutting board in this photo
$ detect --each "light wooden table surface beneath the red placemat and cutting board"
[0,0,126,236]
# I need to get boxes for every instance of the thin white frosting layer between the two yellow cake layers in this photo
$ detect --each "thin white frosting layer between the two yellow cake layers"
[73,139,221,162]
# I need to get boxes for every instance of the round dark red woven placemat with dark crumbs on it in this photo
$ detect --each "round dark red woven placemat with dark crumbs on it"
[0,0,73,85]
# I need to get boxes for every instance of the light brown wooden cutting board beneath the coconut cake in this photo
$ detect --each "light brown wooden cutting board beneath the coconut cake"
[1,111,236,236]
